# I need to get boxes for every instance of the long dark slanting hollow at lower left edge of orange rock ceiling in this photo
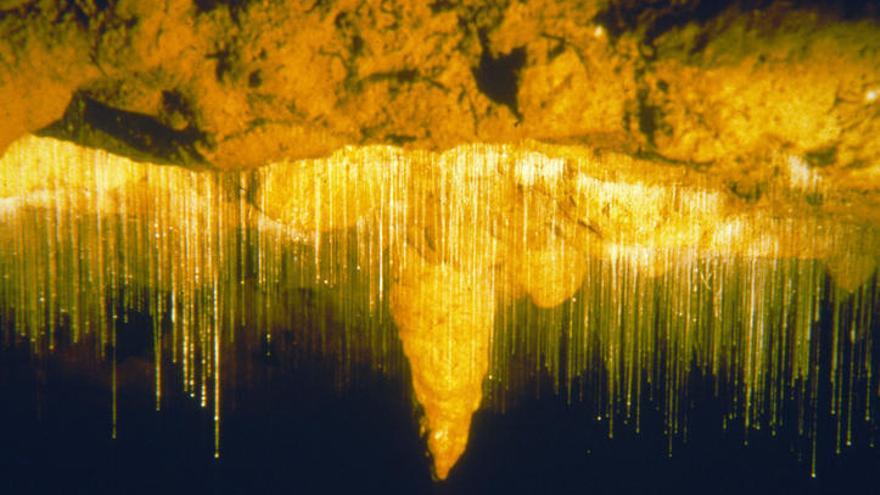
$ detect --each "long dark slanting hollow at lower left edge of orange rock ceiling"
[37,93,206,166]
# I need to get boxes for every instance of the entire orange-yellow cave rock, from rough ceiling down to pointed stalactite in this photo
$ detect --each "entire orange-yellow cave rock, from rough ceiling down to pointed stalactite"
[0,0,880,484]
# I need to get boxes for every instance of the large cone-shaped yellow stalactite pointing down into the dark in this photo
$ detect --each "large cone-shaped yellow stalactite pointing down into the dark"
[389,248,495,479]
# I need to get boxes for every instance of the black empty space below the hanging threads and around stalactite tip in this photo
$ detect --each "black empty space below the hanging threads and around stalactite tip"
[0,326,880,494]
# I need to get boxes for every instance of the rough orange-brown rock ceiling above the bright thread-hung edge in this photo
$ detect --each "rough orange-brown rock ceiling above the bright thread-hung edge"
[0,0,880,182]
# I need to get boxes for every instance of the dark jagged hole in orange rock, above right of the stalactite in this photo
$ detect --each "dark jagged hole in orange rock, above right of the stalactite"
[473,36,526,119]
